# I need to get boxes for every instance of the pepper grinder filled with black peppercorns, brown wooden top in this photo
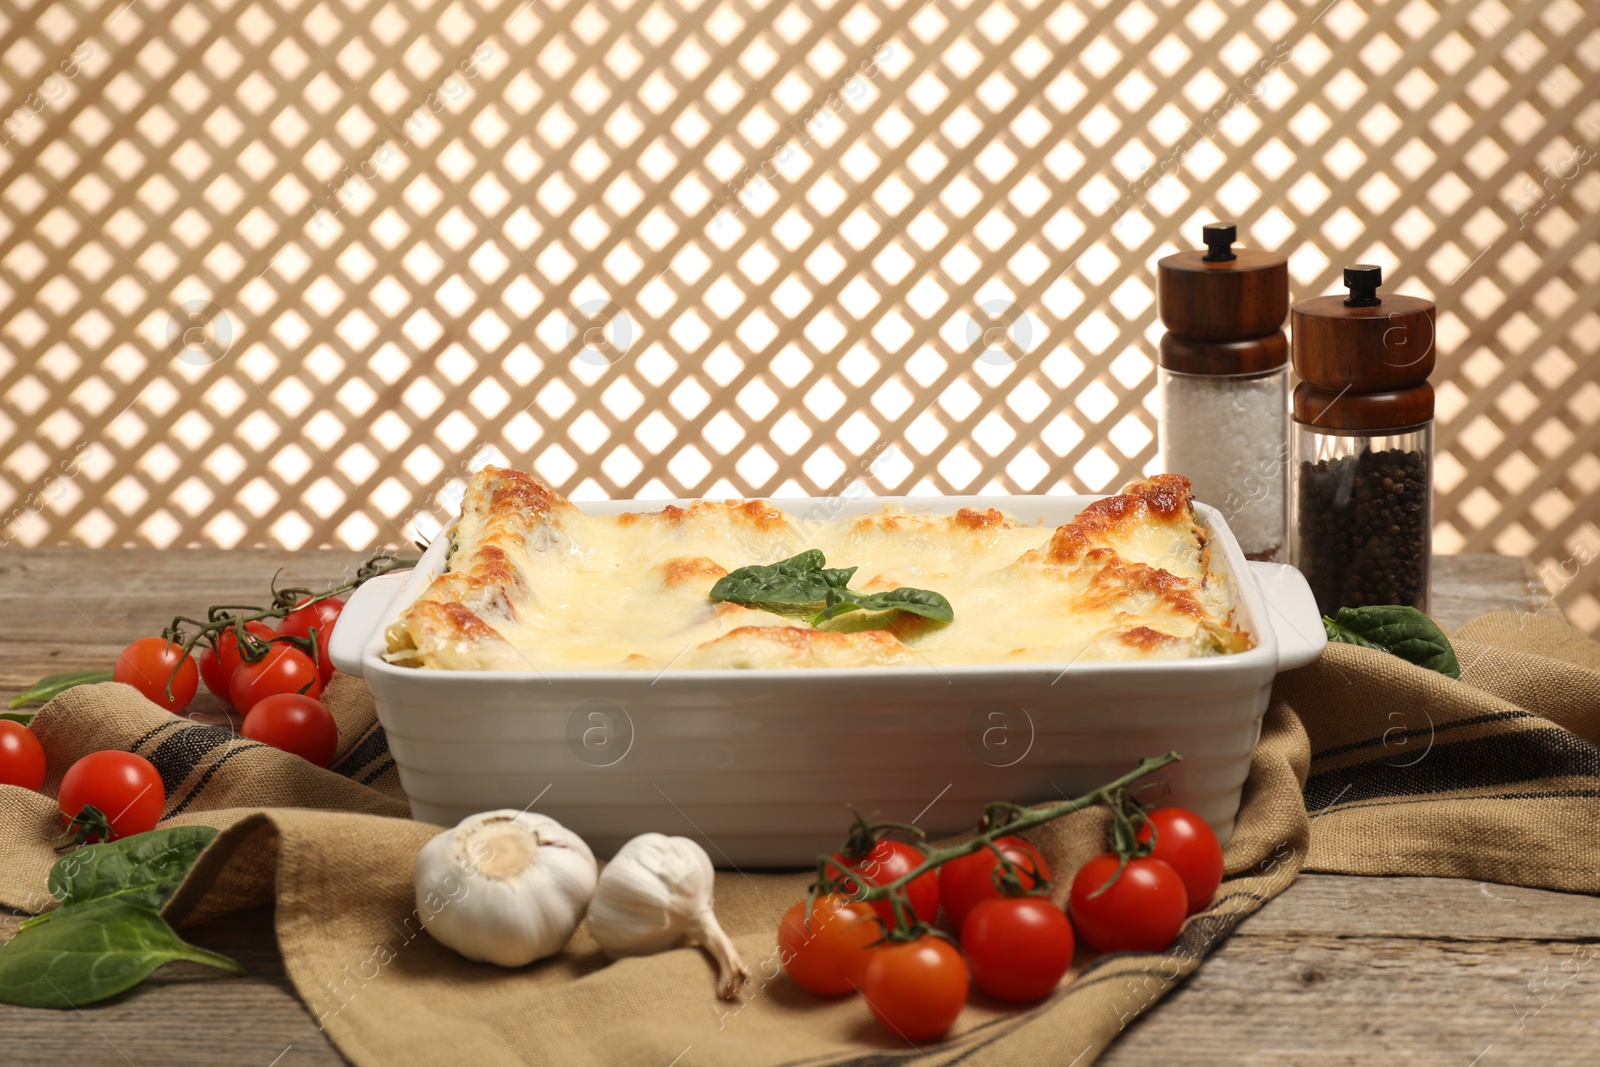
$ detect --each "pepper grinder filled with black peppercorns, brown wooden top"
[1290,264,1435,614]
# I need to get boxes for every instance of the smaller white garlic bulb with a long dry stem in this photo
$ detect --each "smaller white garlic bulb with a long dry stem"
[589,833,750,1000]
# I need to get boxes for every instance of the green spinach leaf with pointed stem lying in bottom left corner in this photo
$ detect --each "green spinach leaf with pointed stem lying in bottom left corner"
[0,899,245,1008]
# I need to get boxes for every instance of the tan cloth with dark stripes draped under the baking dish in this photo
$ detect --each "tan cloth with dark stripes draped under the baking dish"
[0,613,1600,1067]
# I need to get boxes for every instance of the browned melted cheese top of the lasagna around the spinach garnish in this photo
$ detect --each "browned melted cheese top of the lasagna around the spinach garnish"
[387,467,1251,670]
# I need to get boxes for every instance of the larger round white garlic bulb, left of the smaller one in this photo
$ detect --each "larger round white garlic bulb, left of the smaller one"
[416,808,595,966]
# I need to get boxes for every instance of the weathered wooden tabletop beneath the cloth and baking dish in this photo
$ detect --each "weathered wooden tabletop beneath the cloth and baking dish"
[0,549,1600,1067]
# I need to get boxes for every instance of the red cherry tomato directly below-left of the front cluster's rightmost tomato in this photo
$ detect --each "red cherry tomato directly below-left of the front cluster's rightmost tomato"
[1070,853,1189,952]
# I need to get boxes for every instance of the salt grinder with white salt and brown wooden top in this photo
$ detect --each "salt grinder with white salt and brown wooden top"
[1157,222,1290,560]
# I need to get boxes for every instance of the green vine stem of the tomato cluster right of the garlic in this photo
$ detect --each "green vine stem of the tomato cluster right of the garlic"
[808,752,1182,941]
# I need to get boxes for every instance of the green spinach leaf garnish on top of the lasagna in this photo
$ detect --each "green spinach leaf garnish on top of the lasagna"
[710,549,955,625]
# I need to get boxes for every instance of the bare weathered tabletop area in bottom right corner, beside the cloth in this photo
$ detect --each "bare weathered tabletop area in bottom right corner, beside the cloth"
[1101,875,1600,1067]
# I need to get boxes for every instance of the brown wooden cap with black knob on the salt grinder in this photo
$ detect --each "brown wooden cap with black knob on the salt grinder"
[1155,222,1290,348]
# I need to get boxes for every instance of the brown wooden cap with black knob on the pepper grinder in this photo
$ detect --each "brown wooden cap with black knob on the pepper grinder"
[1290,264,1435,392]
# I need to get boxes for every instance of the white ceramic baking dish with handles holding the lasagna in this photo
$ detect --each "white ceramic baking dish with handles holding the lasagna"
[331,496,1326,867]
